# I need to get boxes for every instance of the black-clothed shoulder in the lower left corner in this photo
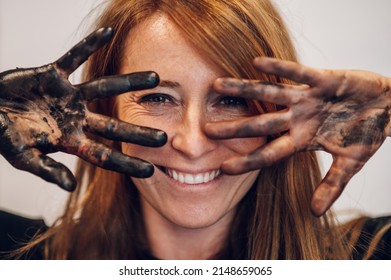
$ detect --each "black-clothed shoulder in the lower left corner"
[0,211,47,259]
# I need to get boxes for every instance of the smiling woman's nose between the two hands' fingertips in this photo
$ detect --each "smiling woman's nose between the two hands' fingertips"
[172,106,218,159]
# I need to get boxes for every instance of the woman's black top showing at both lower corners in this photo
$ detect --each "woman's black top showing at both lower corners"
[0,211,391,260]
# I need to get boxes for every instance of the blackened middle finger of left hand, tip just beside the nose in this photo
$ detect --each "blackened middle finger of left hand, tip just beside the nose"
[86,112,167,147]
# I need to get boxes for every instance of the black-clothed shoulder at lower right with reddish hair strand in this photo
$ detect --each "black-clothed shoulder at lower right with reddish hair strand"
[352,216,391,260]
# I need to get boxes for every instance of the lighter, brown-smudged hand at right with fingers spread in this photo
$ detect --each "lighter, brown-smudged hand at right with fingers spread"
[205,58,391,216]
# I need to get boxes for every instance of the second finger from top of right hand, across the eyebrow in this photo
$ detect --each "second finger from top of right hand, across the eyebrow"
[213,78,304,106]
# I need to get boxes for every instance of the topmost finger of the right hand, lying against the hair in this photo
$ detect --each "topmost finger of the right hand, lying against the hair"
[254,57,320,86]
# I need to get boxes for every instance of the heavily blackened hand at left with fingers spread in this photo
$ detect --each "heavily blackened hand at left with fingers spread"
[0,28,167,191]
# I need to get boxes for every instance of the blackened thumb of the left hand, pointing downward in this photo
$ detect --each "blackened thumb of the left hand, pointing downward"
[10,149,76,192]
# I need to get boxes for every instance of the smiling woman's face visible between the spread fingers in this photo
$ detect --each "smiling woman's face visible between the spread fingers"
[117,15,265,229]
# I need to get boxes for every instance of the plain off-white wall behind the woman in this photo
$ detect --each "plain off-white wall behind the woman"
[0,0,391,223]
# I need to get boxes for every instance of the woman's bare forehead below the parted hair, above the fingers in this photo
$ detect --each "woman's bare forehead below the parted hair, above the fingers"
[121,14,221,74]
